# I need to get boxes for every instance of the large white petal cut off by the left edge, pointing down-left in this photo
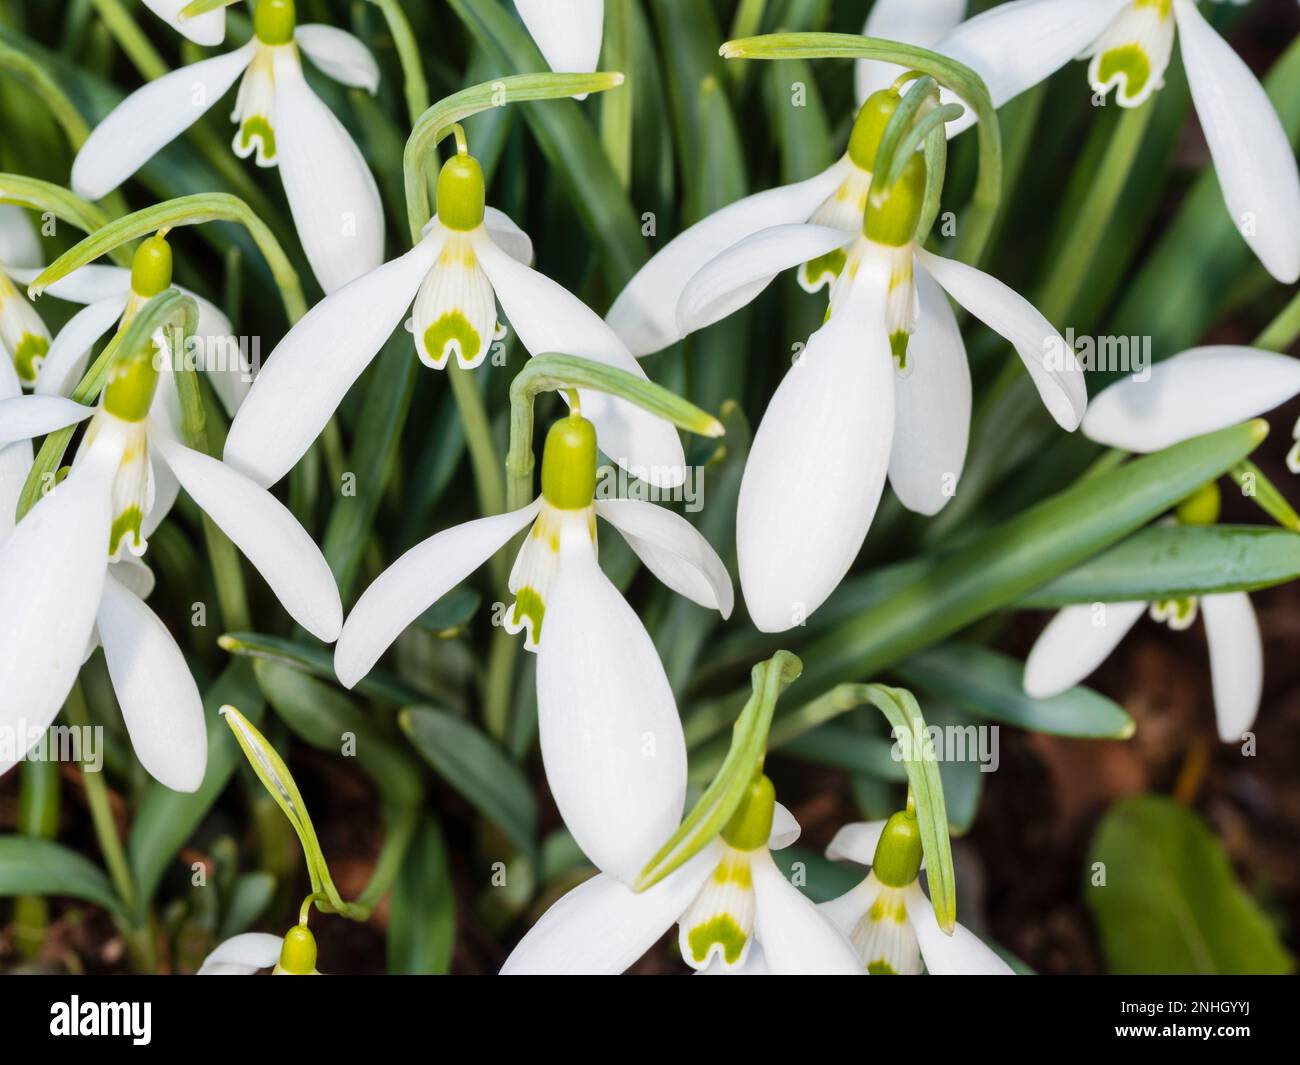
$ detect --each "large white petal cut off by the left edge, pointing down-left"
[0,437,121,772]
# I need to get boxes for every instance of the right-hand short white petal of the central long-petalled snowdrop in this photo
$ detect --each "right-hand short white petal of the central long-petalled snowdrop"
[595,499,736,618]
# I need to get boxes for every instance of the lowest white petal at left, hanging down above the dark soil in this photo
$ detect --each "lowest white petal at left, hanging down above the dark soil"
[96,567,208,792]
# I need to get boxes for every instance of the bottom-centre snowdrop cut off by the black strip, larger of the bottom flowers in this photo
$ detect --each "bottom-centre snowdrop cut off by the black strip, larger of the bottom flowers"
[502,775,862,975]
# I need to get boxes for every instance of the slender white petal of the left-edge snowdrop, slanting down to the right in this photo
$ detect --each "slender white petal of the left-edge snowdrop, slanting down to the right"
[150,432,343,644]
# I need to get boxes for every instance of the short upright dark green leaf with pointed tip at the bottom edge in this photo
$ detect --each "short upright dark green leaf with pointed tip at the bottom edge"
[387,817,456,975]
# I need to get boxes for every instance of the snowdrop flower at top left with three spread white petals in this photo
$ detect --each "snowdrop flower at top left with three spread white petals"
[72,0,384,293]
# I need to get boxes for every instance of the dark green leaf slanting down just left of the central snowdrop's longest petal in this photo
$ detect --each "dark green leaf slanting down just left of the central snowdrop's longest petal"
[398,706,537,854]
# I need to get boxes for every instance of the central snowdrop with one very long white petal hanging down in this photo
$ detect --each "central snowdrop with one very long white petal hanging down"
[334,415,733,876]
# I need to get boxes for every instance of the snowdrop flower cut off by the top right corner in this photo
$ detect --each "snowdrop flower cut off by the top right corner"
[935,0,1300,283]
